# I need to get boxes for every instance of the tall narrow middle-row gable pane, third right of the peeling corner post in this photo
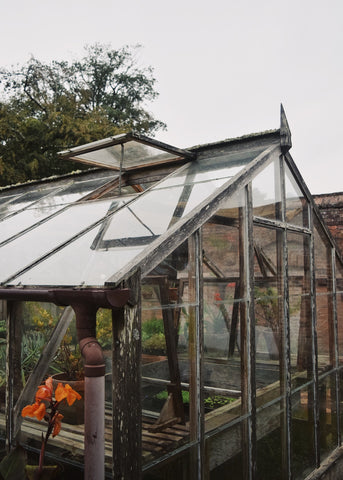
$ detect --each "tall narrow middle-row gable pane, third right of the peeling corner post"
[254,227,285,397]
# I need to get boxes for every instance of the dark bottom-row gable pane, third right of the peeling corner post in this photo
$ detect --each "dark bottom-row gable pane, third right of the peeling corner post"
[256,402,287,480]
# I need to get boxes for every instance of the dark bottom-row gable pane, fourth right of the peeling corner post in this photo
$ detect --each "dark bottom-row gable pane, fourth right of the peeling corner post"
[291,383,315,480]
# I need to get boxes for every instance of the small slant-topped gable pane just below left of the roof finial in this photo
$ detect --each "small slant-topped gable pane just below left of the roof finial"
[251,158,281,219]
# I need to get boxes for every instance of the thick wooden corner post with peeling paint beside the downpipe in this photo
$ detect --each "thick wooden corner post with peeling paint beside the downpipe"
[112,271,142,480]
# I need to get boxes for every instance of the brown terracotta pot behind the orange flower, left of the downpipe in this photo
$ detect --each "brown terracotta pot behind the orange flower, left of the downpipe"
[52,373,85,425]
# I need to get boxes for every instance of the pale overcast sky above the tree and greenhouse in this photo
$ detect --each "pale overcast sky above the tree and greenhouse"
[0,0,343,193]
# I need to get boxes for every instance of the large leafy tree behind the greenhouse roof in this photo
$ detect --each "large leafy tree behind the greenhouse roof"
[0,44,165,185]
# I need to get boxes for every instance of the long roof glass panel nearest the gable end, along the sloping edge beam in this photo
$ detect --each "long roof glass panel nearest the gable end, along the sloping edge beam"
[6,142,263,286]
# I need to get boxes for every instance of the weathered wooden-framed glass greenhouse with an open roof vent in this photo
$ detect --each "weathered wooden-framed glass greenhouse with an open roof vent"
[0,107,343,480]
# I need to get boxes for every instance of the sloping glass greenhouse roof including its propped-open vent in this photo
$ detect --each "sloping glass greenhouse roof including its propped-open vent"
[0,110,304,288]
